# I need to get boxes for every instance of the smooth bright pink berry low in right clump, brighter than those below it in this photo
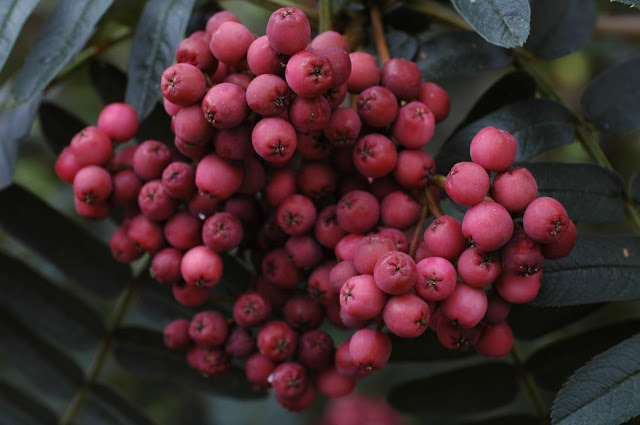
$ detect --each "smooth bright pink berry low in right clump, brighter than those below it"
[439,282,487,329]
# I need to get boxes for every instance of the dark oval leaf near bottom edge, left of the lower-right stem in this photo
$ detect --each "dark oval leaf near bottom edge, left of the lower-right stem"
[388,363,518,415]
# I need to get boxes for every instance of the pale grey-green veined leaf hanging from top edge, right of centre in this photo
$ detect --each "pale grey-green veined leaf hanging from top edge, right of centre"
[451,0,531,48]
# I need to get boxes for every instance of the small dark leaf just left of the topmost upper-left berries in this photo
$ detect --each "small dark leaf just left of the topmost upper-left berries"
[38,102,88,154]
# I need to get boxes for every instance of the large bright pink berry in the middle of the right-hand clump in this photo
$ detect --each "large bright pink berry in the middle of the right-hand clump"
[462,201,513,251]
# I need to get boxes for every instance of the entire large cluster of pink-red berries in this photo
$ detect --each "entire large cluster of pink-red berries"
[56,8,575,411]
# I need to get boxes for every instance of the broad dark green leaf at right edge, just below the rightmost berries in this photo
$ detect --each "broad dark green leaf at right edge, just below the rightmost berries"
[532,235,640,306]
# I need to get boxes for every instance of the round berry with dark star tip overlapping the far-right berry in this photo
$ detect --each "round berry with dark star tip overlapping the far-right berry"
[522,196,569,243]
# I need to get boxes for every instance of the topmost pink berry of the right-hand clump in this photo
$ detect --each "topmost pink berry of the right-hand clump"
[469,127,518,173]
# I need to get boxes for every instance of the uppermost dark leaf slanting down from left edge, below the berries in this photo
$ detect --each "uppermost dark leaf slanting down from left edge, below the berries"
[0,185,131,296]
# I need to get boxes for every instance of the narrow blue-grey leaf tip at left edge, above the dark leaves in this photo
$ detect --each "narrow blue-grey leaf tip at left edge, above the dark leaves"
[0,88,41,190]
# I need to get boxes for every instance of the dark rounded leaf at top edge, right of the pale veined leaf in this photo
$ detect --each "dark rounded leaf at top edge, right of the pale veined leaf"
[524,0,598,59]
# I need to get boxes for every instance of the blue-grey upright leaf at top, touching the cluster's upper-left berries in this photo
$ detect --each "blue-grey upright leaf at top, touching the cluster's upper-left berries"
[125,0,194,120]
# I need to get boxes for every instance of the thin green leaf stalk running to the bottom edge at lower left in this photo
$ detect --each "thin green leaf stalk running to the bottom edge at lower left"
[58,279,140,425]
